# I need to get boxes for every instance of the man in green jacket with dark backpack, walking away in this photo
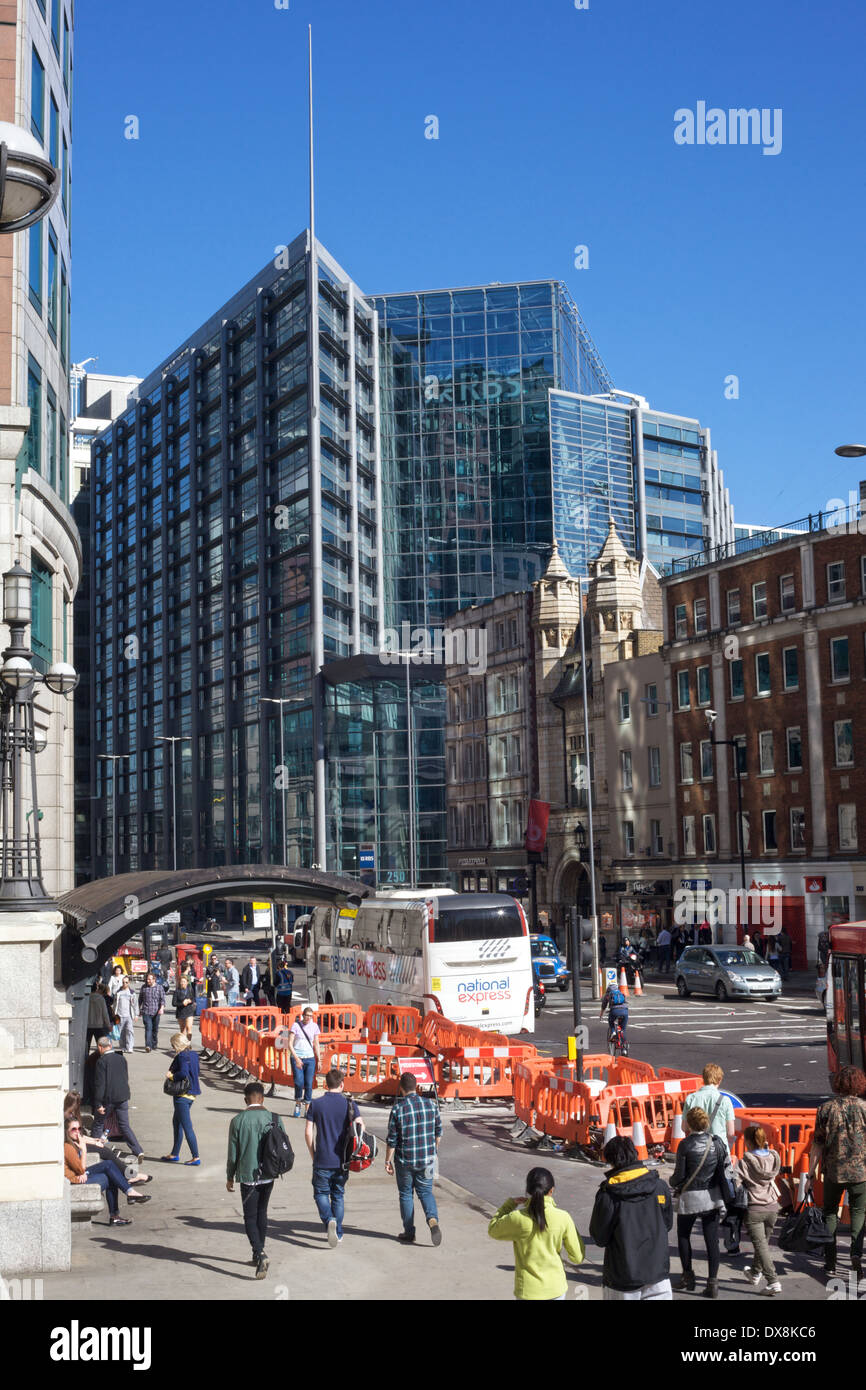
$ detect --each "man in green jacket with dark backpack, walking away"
[225,1081,295,1279]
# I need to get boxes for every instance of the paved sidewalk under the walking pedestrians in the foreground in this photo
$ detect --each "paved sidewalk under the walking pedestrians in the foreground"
[44,1022,847,1307]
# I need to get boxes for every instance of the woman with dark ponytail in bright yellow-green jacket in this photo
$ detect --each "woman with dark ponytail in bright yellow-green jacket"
[487,1168,584,1300]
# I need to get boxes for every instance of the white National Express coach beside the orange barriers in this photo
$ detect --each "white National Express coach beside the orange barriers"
[307,888,535,1033]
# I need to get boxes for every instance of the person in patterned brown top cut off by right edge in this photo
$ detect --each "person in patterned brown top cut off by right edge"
[809,1066,866,1279]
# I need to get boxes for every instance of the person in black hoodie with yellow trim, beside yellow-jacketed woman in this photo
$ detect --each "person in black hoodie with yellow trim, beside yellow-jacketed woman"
[589,1136,674,1301]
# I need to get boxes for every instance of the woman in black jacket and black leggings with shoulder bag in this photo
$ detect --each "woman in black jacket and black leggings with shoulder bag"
[670,1105,728,1298]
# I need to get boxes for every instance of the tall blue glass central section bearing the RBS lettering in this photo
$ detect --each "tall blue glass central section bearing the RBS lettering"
[373,281,612,628]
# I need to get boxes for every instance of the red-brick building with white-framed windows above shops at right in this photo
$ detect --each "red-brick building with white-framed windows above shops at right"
[662,518,866,967]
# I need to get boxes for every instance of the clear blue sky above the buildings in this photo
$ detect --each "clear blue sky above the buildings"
[72,0,866,524]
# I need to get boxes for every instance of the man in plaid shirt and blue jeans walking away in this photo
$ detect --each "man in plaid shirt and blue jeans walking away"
[385,1072,442,1245]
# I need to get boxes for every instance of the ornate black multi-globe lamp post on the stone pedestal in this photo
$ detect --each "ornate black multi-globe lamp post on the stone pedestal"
[0,558,78,912]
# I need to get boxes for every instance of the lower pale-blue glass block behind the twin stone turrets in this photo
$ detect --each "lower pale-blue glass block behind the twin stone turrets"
[550,391,734,574]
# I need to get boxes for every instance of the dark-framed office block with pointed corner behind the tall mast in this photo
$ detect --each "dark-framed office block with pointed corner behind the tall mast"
[86,232,382,874]
